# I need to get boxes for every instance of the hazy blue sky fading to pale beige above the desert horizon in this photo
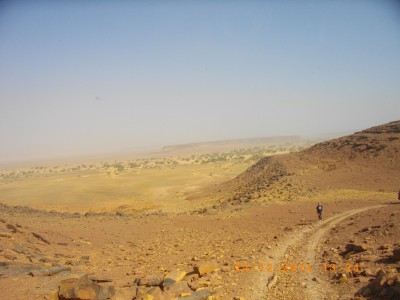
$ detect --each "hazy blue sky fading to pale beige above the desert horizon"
[0,0,400,162]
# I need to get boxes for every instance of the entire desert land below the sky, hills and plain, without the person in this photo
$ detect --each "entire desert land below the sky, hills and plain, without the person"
[0,121,400,300]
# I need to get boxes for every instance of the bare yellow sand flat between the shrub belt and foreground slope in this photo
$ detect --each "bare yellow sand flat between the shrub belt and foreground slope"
[0,161,251,214]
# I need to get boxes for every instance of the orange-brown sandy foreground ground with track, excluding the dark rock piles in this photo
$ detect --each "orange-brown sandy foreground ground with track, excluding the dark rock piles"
[0,200,400,299]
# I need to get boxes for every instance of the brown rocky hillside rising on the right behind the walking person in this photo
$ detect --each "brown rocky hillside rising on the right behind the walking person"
[214,121,400,204]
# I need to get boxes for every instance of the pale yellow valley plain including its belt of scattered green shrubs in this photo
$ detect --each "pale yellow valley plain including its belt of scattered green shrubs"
[0,138,322,210]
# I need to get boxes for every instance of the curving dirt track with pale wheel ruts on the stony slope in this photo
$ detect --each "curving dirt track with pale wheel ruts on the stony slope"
[248,205,384,300]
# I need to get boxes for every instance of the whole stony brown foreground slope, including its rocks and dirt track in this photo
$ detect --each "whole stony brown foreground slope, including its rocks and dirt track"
[0,201,400,299]
